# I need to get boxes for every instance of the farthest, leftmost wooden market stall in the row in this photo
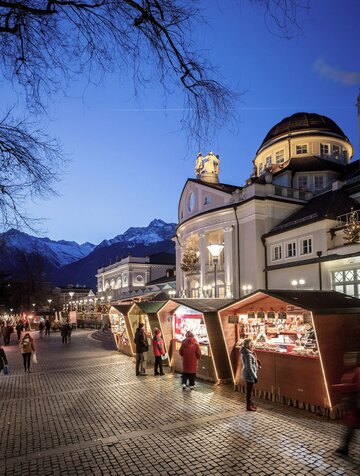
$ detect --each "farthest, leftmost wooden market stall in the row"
[109,303,133,357]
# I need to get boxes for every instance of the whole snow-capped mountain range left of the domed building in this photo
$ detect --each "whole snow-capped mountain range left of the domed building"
[0,219,176,286]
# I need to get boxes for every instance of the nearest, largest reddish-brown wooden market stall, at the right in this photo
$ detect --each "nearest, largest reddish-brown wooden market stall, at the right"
[219,290,360,416]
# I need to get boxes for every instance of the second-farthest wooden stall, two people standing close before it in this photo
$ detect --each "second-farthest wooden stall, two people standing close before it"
[128,301,169,365]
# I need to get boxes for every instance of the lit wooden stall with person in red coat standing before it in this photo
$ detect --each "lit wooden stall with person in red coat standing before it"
[158,299,234,382]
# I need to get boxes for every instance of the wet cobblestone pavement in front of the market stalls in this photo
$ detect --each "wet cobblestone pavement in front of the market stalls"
[0,330,360,476]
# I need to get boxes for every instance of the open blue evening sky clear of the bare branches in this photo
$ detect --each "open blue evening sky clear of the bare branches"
[19,0,360,244]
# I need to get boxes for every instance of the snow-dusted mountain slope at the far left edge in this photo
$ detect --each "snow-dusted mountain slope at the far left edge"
[0,229,95,268]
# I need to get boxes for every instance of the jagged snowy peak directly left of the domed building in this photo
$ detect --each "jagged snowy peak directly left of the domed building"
[96,218,176,249]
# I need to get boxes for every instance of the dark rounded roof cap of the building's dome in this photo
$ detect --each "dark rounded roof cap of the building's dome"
[259,112,349,150]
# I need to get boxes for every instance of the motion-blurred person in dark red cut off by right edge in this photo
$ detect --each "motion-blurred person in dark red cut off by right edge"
[335,352,360,456]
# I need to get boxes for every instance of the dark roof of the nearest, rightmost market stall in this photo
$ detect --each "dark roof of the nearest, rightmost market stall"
[238,289,360,314]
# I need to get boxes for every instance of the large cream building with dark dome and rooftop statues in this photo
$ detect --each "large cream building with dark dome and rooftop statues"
[175,112,360,298]
